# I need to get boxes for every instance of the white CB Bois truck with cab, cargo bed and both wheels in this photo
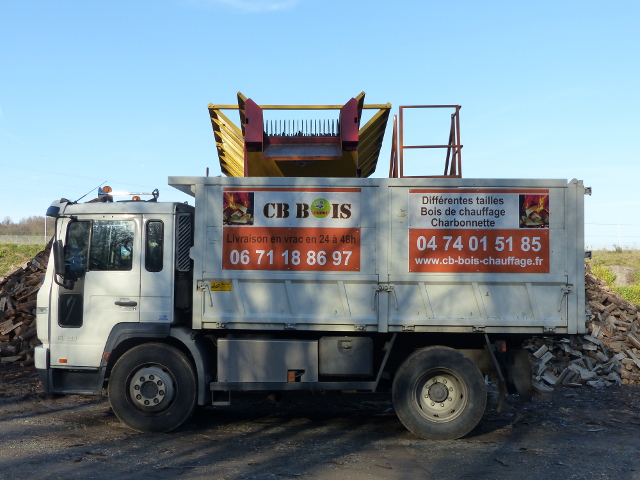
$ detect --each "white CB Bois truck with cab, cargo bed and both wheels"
[35,97,585,438]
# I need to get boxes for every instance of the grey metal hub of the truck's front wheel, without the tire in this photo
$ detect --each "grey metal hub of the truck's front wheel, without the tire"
[129,366,175,410]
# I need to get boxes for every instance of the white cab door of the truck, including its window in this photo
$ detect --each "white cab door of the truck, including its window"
[50,215,141,367]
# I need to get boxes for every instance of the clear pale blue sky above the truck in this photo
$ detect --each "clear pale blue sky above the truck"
[0,0,640,248]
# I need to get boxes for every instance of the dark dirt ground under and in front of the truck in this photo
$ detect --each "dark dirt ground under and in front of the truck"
[0,366,640,480]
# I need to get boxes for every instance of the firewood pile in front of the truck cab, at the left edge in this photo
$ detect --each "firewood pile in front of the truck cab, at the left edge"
[0,244,51,366]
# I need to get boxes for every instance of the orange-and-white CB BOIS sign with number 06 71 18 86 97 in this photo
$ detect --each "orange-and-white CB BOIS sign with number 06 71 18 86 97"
[222,187,360,271]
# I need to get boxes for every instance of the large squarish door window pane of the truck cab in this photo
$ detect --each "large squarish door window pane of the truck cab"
[89,220,134,271]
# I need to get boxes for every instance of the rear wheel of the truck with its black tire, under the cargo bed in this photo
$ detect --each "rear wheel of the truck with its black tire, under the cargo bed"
[393,346,487,440]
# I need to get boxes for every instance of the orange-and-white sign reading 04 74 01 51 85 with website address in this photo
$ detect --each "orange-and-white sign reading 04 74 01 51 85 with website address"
[408,189,550,273]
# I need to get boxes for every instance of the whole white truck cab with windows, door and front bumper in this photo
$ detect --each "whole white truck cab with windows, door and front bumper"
[36,195,199,394]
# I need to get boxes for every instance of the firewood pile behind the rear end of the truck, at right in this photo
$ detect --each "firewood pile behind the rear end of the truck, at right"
[525,268,640,394]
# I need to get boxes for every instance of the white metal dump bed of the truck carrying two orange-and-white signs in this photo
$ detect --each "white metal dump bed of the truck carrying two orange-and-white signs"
[169,177,585,334]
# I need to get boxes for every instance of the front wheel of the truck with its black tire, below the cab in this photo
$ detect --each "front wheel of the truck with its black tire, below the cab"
[109,343,197,433]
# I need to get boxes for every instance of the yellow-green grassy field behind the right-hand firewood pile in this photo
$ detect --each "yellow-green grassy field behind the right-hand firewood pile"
[591,248,640,305]
